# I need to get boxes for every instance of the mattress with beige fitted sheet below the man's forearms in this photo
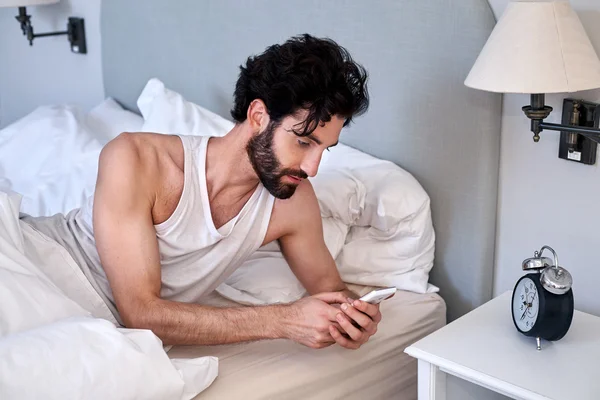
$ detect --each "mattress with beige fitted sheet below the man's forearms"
[168,285,446,400]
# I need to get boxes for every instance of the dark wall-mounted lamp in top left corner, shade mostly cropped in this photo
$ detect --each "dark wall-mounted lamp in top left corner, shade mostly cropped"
[0,0,87,54]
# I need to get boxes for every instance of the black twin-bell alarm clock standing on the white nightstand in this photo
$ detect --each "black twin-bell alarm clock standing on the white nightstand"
[511,246,574,350]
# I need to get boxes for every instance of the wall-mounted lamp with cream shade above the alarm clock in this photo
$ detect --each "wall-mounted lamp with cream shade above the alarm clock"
[465,0,600,164]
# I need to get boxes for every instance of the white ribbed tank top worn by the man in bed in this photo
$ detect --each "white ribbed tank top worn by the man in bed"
[149,136,274,302]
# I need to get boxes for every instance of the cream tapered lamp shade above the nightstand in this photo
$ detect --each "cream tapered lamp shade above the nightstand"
[465,0,600,94]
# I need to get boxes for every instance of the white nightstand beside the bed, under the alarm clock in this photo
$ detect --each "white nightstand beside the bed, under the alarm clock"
[405,291,600,400]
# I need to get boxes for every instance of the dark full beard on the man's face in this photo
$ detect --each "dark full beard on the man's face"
[246,121,308,199]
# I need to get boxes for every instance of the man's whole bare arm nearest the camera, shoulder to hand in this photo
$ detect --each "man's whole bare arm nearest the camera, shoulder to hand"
[93,134,342,348]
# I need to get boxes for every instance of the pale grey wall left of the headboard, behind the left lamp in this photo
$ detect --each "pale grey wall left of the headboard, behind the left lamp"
[0,0,104,127]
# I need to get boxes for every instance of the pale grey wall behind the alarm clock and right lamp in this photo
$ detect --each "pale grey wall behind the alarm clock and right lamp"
[490,0,600,315]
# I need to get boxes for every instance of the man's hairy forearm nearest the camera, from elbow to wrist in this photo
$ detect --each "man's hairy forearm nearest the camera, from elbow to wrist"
[133,299,286,345]
